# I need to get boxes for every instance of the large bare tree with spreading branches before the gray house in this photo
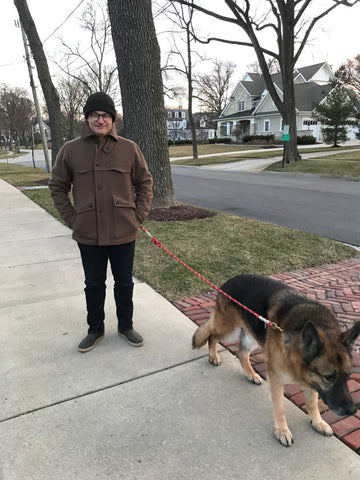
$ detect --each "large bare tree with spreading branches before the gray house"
[170,0,360,162]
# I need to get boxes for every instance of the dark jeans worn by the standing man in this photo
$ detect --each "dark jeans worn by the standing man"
[78,241,135,333]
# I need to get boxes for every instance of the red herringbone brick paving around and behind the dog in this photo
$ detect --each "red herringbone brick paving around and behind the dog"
[173,258,360,454]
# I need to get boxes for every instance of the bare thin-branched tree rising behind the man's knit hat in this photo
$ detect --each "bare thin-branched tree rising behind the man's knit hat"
[55,2,119,101]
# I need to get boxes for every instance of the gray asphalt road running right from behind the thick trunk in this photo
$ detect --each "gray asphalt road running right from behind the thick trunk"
[172,165,360,247]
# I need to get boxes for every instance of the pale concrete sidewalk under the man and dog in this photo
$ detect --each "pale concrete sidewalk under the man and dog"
[0,180,360,480]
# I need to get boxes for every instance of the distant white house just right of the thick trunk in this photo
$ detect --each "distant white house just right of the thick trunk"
[166,108,216,141]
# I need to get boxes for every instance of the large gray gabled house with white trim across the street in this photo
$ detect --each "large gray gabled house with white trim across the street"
[217,62,334,141]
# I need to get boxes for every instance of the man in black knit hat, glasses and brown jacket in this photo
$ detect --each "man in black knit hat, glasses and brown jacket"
[49,92,152,352]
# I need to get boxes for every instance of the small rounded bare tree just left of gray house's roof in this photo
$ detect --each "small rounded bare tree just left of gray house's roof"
[194,60,235,116]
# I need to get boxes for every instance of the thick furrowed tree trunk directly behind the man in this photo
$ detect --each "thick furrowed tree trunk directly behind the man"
[108,0,177,208]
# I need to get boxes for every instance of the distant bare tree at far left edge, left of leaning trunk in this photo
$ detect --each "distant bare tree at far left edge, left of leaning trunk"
[0,85,35,150]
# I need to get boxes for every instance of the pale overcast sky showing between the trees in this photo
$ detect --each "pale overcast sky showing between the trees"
[0,0,360,102]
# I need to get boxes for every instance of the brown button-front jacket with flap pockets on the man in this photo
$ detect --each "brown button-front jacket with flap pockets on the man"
[49,122,152,245]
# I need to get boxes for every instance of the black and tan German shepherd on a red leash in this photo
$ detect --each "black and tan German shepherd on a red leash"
[193,275,360,447]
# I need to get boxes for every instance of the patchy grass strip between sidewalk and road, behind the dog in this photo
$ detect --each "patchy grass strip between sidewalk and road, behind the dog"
[134,213,360,300]
